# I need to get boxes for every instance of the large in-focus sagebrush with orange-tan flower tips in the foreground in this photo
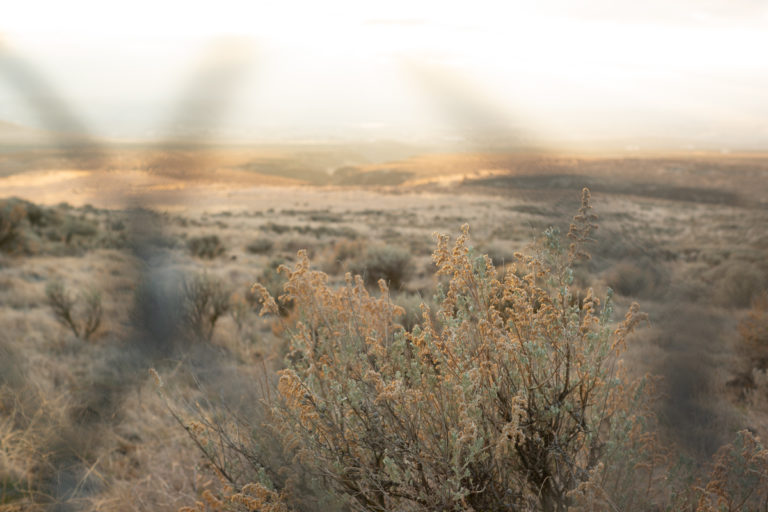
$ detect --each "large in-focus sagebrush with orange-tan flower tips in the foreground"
[249,191,646,511]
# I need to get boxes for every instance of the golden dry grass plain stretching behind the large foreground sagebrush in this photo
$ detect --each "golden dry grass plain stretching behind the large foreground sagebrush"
[0,144,768,511]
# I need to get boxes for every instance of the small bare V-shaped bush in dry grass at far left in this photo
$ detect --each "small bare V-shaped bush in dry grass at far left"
[45,281,102,341]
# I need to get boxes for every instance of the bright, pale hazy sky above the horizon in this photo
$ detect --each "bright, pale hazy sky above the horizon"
[0,0,768,149]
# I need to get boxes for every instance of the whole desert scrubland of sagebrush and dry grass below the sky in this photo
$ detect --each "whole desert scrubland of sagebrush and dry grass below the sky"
[0,144,768,511]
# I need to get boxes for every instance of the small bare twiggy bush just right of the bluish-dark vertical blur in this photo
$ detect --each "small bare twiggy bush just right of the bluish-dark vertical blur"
[183,274,231,341]
